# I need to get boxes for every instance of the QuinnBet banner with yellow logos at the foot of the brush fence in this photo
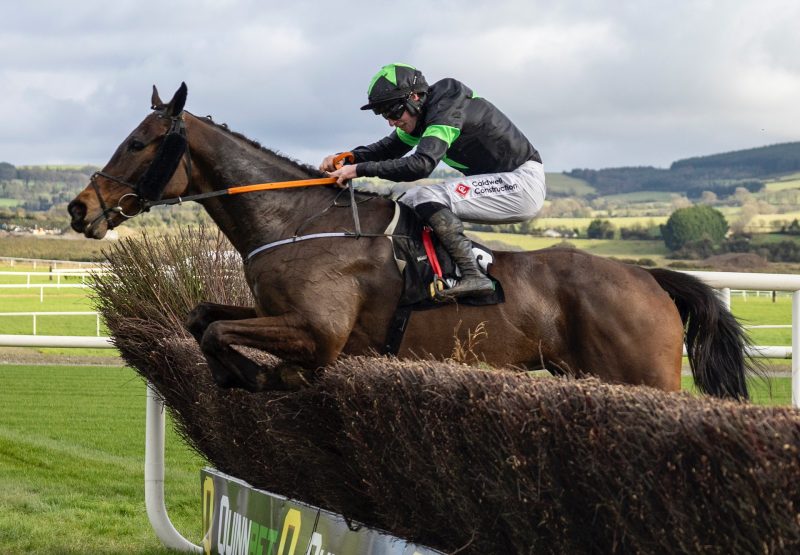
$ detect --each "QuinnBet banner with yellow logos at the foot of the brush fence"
[200,468,440,555]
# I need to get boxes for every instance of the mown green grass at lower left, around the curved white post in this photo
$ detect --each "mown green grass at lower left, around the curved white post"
[0,365,204,554]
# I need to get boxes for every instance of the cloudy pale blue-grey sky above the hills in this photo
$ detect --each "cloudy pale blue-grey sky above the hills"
[0,0,800,171]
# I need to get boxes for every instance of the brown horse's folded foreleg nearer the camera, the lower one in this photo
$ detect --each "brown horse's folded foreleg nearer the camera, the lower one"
[200,315,349,392]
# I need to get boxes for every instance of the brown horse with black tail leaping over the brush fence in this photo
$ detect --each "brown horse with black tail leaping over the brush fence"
[69,84,751,399]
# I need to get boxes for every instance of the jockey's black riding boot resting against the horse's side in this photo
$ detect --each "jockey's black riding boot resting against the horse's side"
[428,208,494,298]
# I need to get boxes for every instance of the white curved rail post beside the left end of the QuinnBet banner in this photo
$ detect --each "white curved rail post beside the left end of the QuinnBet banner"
[144,383,203,553]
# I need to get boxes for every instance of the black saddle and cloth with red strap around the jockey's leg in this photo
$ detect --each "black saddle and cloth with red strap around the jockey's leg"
[384,202,505,355]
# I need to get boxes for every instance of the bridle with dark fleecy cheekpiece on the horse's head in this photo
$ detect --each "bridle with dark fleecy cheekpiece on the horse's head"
[89,111,192,233]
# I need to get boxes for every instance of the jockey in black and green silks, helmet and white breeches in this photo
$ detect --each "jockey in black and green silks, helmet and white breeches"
[320,64,545,298]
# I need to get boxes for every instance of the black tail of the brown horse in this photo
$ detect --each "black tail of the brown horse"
[649,268,755,399]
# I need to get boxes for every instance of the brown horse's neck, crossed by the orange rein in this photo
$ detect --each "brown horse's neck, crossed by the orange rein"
[187,118,332,254]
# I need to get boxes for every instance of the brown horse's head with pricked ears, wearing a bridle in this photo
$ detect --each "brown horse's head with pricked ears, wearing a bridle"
[67,83,190,239]
